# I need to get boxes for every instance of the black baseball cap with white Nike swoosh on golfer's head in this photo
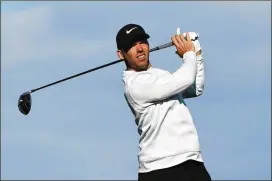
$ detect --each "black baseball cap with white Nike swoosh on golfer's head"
[116,24,150,52]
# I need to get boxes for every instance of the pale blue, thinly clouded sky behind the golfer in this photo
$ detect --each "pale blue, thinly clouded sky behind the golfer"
[1,1,271,180]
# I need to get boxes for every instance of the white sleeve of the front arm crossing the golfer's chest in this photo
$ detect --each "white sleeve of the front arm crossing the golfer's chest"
[127,51,197,103]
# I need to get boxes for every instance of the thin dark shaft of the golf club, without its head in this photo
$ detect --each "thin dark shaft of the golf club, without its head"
[29,42,173,93]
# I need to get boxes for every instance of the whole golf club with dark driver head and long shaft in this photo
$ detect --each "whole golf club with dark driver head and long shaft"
[18,42,173,115]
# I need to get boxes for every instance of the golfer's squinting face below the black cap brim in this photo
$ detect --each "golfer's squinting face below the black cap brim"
[119,40,151,71]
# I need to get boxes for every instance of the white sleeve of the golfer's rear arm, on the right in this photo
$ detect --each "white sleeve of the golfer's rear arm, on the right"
[181,54,205,98]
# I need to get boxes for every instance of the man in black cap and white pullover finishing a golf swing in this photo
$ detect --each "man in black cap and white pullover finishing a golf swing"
[116,24,211,181]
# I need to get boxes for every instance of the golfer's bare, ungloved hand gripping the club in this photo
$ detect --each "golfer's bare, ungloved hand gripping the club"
[171,33,195,57]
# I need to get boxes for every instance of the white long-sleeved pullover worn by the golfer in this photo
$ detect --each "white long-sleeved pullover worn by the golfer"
[123,51,204,173]
